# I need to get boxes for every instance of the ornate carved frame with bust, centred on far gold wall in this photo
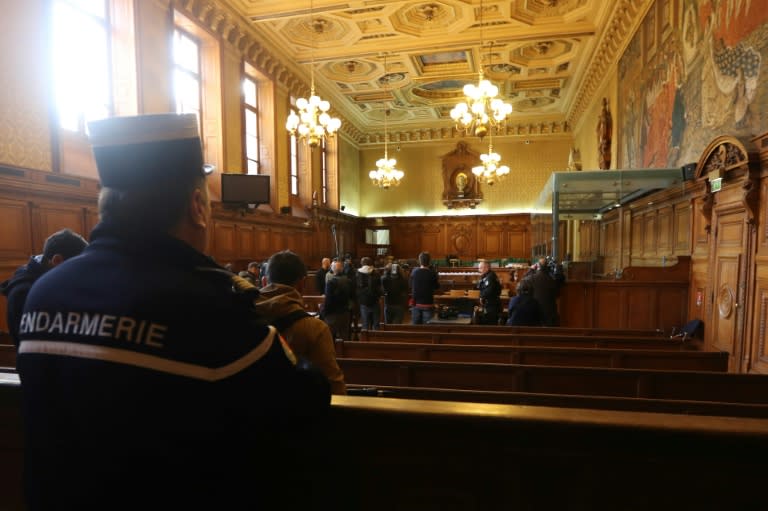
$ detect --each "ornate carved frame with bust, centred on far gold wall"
[441,141,483,209]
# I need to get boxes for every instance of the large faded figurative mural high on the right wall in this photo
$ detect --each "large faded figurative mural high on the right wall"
[617,0,768,168]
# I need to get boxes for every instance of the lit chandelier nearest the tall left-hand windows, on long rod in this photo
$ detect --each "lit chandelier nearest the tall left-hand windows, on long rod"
[285,2,341,148]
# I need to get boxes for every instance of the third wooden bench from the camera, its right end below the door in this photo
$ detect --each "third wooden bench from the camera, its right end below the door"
[335,340,728,372]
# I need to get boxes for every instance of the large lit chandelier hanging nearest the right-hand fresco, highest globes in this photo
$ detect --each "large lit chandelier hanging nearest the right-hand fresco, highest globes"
[451,0,512,140]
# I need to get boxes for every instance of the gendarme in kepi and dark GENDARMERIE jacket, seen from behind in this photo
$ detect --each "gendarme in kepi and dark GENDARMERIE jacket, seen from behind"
[17,114,330,511]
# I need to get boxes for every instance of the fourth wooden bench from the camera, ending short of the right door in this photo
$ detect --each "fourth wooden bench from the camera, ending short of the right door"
[360,330,701,350]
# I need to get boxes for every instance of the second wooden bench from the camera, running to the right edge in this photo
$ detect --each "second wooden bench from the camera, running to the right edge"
[337,358,768,404]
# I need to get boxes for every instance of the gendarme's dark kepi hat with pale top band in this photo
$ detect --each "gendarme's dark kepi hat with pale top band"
[88,114,213,190]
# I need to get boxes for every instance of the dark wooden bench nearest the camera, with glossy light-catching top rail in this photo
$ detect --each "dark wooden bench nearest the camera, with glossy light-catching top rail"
[0,374,768,511]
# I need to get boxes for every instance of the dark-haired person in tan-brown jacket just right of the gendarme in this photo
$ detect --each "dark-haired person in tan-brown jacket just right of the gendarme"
[255,250,347,394]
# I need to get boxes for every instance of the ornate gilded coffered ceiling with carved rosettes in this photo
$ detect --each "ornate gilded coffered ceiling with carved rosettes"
[213,0,648,144]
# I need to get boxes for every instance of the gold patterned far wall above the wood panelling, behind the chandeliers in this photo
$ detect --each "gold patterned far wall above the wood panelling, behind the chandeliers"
[359,135,571,217]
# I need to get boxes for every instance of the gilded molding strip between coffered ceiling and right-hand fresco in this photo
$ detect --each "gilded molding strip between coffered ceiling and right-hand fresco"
[567,0,655,126]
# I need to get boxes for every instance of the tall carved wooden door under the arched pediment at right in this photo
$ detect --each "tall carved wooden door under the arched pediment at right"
[706,207,749,372]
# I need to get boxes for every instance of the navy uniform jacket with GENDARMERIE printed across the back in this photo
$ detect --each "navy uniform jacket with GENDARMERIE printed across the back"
[18,223,330,510]
